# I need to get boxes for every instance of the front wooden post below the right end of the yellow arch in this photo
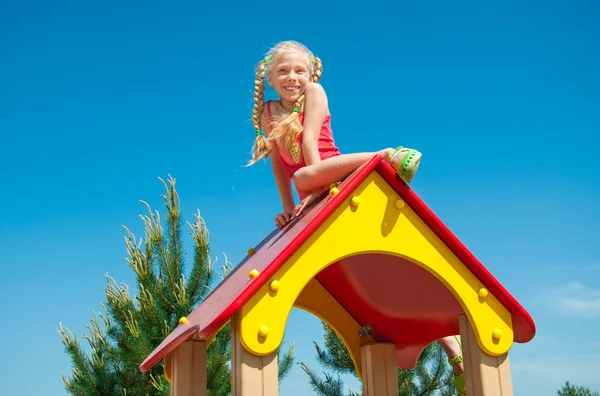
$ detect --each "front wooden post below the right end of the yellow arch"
[459,314,513,396]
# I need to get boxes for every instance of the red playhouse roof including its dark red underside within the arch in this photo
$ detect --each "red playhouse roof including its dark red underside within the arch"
[140,155,535,371]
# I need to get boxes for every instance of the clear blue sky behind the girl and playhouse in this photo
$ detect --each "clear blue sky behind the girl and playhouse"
[0,1,600,396]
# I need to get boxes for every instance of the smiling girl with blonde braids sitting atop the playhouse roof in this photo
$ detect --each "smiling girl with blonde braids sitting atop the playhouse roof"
[250,41,464,394]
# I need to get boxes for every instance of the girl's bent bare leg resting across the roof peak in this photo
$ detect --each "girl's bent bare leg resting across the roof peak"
[292,148,396,193]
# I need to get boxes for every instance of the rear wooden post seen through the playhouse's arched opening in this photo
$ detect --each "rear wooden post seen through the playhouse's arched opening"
[360,343,398,396]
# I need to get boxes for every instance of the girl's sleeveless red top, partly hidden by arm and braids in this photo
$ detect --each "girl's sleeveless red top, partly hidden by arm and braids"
[267,101,340,199]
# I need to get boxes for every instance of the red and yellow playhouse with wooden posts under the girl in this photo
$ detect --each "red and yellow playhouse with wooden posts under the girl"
[140,155,535,396]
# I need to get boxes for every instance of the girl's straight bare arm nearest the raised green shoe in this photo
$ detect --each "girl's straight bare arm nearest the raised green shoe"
[302,83,327,165]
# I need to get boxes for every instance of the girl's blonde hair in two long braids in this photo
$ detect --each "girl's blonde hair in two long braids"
[250,41,323,164]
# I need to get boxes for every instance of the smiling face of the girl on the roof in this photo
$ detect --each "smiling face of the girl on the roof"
[267,52,310,103]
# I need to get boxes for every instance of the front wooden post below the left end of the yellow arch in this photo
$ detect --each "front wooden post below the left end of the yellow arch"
[231,313,279,396]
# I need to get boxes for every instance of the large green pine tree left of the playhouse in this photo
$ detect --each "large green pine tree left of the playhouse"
[59,176,294,396]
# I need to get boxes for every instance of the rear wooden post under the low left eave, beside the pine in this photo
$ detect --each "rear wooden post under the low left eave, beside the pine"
[165,340,206,396]
